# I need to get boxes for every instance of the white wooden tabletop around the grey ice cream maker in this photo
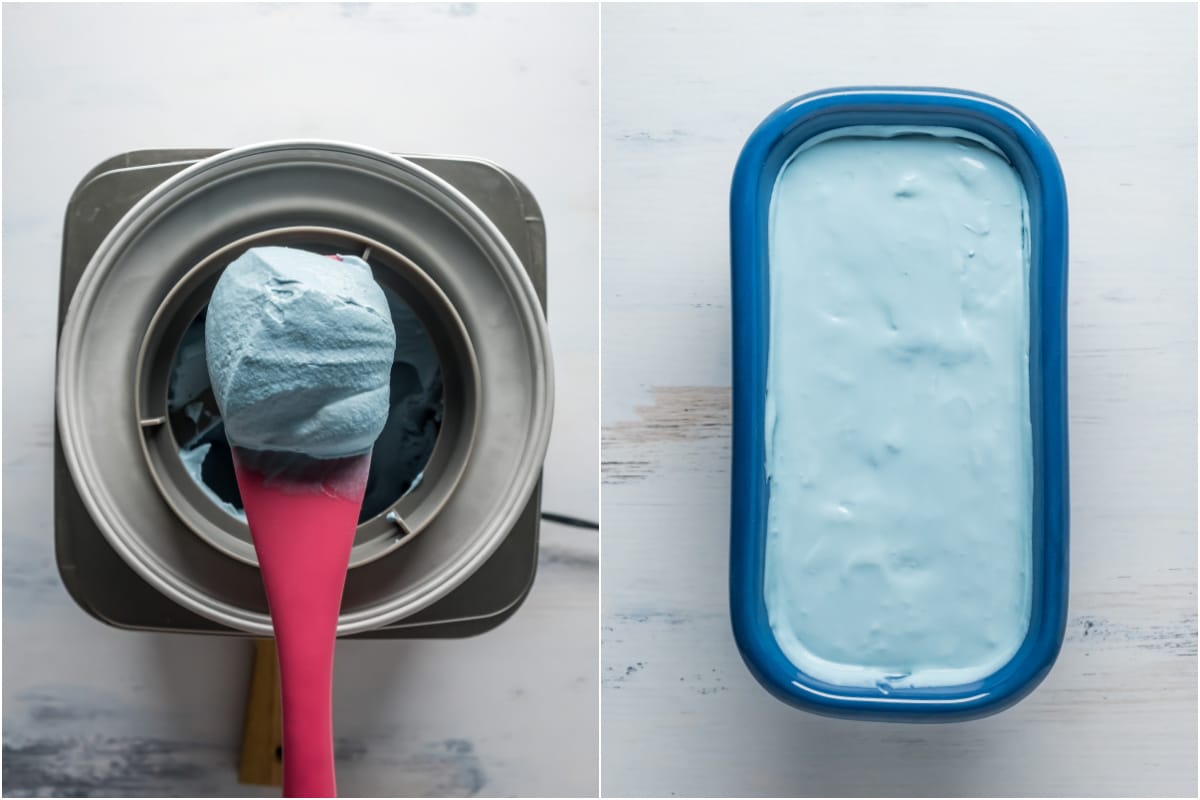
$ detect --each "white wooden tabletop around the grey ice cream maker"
[4,4,599,796]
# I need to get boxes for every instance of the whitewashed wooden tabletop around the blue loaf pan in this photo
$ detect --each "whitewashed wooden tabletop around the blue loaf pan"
[601,4,1196,798]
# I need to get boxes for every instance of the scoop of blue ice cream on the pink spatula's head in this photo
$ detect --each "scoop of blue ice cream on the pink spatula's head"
[204,247,396,459]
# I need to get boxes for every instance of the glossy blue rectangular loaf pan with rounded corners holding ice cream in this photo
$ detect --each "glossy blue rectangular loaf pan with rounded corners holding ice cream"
[730,88,1069,722]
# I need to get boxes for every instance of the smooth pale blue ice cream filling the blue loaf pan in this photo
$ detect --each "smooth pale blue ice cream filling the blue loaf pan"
[763,128,1033,693]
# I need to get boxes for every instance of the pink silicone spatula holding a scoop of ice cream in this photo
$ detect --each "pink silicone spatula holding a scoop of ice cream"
[233,447,371,798]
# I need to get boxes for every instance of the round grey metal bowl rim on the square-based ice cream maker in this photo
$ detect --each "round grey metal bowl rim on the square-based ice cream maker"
[59,143,552,634]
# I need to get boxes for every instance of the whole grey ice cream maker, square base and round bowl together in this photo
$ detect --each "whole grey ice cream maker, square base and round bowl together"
[55,142,553,636]
